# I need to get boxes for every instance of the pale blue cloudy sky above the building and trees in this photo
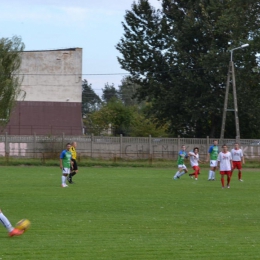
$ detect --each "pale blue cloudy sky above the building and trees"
[0,0,160,95]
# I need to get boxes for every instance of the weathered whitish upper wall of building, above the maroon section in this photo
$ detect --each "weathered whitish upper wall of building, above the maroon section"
[18,48,82,102]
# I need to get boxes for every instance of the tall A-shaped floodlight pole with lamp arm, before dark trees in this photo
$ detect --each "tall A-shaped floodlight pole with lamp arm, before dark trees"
[220,43,249,142]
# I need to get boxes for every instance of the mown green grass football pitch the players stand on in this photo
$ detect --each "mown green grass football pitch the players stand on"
[0,166,260,260]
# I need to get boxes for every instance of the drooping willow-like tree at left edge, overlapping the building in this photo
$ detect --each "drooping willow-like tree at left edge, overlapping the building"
[0,36,24,126]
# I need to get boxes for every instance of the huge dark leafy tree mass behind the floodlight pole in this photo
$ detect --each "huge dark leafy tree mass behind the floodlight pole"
[116,0,260,138]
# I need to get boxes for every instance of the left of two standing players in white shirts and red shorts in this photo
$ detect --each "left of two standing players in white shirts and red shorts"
[217,144,232,189]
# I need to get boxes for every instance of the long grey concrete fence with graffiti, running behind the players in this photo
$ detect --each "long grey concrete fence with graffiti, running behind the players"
[0,133,260,160]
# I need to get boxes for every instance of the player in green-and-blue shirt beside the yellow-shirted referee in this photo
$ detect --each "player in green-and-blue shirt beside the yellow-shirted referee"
[60,143,73,188]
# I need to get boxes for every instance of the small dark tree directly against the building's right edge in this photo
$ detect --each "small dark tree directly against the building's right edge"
[82,79,101,117]
